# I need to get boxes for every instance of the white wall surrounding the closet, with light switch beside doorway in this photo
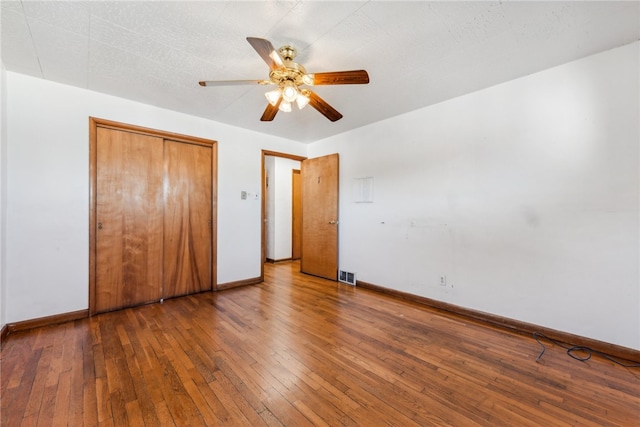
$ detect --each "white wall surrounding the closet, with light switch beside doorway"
[3,72,306,323]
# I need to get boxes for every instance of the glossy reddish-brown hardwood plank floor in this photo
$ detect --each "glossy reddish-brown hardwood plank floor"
[1,263,640,426]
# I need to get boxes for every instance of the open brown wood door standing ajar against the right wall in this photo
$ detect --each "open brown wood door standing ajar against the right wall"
[300,154,339,280]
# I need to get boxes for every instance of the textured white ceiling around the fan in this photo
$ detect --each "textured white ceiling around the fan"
[1,0,640,142]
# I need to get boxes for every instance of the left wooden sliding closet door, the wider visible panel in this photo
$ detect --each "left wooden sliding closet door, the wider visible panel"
[94,128,163,313]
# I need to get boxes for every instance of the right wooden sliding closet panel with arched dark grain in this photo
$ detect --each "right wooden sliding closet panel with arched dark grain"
[163,140,212,298]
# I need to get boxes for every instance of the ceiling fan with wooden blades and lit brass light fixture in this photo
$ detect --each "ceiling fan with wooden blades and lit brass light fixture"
[199,37,369,122]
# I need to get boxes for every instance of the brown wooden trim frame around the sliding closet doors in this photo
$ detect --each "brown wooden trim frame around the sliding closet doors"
[89,117,218,315]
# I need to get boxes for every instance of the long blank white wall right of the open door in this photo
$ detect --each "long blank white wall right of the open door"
[308,42,640,349]
